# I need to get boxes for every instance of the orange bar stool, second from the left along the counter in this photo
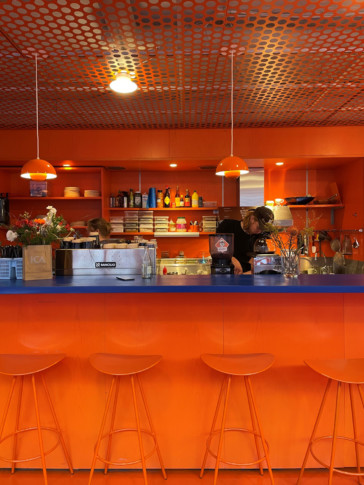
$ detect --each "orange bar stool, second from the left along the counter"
[88,354,167,485]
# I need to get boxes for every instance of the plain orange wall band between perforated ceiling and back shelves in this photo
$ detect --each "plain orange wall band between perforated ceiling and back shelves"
[0,126,364,163]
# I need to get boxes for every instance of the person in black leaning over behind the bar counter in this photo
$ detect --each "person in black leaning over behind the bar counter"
[216,206,274,274]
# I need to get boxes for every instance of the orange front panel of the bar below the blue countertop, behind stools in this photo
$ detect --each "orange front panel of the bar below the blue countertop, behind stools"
[0,293,364,469]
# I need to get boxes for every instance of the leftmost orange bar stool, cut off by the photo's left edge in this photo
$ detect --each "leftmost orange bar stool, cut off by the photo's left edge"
[0,354,73,485]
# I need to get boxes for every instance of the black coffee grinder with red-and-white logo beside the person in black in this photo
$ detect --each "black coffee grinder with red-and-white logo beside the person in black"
[209,234,234,274]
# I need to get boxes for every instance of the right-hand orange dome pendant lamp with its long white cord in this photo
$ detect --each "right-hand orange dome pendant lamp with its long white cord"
[216,50,249,178]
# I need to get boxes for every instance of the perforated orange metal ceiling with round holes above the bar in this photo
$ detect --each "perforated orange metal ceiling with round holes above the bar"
[0,0,364,129]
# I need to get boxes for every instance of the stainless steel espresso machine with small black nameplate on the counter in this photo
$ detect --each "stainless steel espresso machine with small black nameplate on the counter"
[56,247,156,276]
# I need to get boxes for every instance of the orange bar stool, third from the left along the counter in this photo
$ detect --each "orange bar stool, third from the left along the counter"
[200,354,274,485]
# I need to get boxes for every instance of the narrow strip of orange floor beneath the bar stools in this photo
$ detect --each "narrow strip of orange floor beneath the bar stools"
[0,470,357,485]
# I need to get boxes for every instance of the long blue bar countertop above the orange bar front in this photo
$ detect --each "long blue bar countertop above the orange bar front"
[0,274,364,295]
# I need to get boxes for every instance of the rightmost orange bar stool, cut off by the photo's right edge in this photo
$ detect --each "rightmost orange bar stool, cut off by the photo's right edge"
[297,359,364,485]
